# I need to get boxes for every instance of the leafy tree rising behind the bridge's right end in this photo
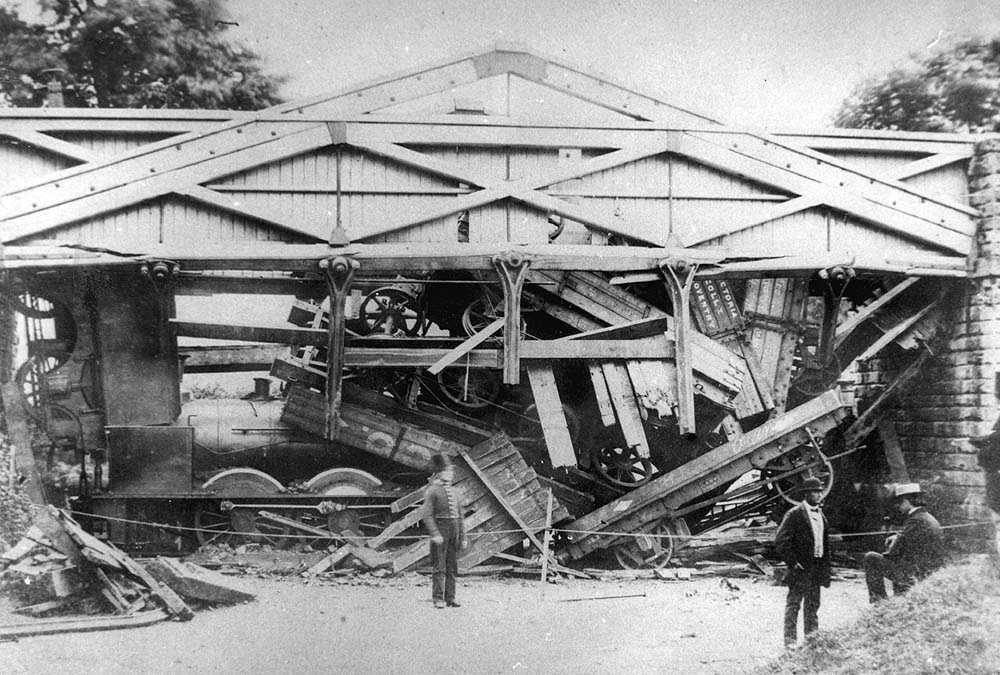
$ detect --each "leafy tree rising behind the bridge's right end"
[834,38,1000,133]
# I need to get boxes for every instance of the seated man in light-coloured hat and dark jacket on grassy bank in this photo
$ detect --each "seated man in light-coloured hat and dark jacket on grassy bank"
[864,483,944,603]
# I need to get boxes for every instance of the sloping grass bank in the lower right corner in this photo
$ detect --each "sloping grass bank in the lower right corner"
[752,557,1000,675]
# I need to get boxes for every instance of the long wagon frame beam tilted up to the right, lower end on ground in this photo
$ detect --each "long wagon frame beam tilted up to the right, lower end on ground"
[557,391,847,562]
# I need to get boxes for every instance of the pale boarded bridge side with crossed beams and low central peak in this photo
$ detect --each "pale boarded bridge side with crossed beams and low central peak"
[0,47,975,264]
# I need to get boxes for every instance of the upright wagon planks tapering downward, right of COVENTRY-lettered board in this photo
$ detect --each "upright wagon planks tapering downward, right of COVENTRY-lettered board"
[743,278,809,413]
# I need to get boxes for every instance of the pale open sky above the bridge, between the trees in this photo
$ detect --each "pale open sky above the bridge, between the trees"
[230,0,1000,128]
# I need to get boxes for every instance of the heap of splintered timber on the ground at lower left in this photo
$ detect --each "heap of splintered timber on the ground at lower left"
[0,506,254,640]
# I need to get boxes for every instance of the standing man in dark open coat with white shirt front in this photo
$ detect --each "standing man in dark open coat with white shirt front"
[774,478,830,647]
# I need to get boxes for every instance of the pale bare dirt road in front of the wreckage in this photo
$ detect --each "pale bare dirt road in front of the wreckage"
[0,576,867,675]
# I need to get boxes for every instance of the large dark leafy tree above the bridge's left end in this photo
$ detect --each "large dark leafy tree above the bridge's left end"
[0,0,283,110]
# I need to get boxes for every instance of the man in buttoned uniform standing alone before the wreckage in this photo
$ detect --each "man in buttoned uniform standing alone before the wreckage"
[424,454,469,609]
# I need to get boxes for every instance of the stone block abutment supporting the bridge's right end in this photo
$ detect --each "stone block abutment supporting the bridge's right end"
[858,139,1000,535]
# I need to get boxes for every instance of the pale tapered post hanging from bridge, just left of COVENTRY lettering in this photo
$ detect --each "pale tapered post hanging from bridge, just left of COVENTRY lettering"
[660,258,698,436]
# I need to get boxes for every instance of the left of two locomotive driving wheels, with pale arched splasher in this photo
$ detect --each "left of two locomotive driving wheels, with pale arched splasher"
[194,469,288,546]
